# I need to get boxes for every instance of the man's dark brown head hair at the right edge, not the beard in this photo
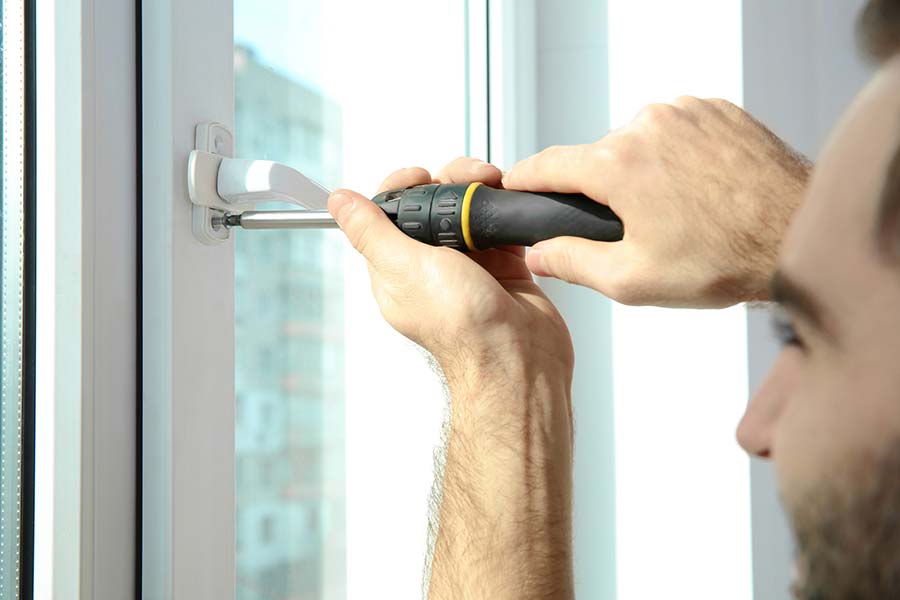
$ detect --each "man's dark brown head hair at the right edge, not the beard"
[856,0,900,260]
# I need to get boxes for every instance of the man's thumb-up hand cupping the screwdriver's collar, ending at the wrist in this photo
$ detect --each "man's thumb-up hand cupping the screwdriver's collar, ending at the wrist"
[328,159,573,380]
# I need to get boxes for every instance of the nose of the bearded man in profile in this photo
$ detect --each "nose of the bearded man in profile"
[737,352,793,458]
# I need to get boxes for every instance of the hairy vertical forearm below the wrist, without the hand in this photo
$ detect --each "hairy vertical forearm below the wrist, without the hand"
[429,361,573,600]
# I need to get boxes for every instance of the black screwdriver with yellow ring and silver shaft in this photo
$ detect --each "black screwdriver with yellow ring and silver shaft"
[221,182,624,252]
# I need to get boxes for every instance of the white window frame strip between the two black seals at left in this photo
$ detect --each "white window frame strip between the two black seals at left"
[34,0,138,600]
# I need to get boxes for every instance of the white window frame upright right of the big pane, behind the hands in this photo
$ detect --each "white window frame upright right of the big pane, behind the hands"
[489,0,617,598]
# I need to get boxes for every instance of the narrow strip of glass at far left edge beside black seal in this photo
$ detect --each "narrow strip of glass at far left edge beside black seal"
[0,2,24,598]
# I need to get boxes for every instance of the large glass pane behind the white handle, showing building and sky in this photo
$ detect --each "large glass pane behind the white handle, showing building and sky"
[234,0,466,600]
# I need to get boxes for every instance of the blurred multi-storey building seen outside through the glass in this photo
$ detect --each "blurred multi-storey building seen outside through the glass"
[234,39,346,600]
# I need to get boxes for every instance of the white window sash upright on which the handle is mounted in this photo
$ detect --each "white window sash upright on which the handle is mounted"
[141,0,235,600]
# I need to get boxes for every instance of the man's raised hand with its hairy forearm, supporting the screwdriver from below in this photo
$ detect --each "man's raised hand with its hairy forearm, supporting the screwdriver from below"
[328,159,574,600]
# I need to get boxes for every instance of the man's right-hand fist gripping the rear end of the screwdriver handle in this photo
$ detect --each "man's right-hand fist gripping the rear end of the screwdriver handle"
[503,97,811,307]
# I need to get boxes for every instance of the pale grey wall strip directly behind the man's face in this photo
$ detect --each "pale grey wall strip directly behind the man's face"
[743,0,870,600]
